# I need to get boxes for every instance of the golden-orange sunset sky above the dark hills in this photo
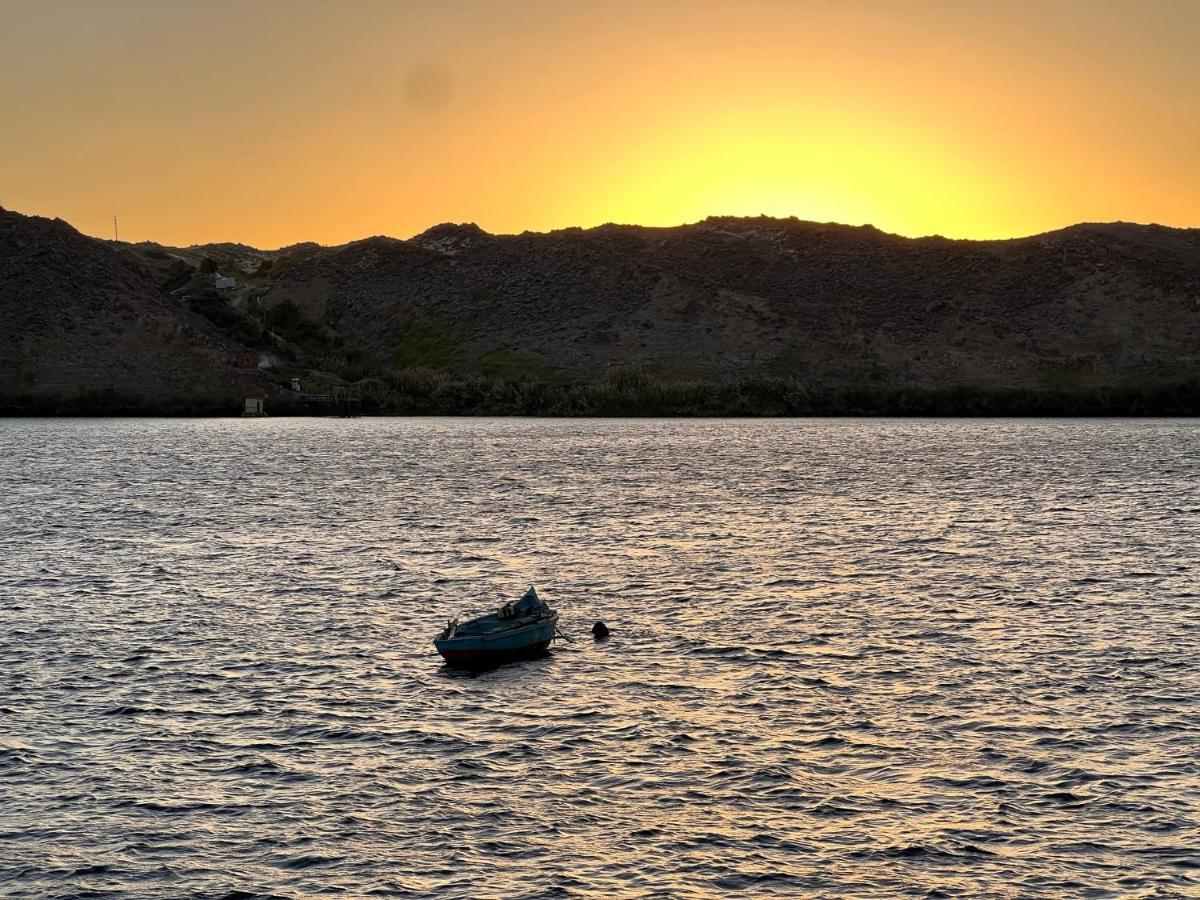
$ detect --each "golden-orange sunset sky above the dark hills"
[0,0,1200,247]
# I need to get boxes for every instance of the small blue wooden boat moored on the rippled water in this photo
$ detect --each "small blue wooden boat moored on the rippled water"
[433,587,558,668]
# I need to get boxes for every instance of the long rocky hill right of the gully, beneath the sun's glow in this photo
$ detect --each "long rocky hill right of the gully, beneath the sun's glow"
[265,218,1200,389]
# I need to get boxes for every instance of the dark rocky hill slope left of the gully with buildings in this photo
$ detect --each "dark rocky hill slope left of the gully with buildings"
[0,210,270,413]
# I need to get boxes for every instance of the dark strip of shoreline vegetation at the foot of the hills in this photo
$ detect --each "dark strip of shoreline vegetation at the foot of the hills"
[0,372,1200,418]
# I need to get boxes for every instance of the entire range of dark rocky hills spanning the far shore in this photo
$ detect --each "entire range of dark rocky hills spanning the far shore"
[0,206,1200,412]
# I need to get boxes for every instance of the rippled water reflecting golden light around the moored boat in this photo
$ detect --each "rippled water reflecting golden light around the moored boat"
[0,419,1200,898]
